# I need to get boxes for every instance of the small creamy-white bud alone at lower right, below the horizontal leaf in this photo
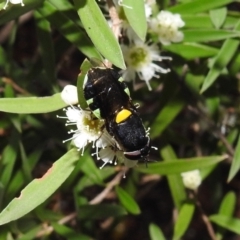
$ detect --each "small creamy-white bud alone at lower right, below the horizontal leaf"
[181,169,202,190]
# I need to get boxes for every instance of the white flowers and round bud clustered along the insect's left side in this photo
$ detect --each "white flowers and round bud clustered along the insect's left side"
[57,85,137,168]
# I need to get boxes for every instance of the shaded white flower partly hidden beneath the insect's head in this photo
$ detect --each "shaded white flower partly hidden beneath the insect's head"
[98,146,138,169]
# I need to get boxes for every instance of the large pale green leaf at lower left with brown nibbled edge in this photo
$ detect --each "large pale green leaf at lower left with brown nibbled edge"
[0,149,79,225]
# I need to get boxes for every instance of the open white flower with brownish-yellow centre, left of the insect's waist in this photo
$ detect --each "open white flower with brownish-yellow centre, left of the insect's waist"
[58,107,104,155]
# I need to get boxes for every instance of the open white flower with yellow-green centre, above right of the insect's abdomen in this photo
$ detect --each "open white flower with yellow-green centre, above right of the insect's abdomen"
[121,39,171,90]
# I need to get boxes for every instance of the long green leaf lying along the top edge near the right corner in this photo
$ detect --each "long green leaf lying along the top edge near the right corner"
[167,0,235,14]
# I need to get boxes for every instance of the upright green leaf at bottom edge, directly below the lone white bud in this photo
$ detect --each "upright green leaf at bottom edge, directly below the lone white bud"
[173,202,195,240]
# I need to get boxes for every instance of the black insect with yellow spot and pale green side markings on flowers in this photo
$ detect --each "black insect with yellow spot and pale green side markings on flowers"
[83,67,150,161]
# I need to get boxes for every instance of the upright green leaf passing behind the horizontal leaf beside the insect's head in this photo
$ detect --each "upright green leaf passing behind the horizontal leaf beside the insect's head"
[161,145,187,209]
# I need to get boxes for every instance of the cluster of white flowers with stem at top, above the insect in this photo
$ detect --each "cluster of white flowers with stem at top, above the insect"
[109,0,184,90]
